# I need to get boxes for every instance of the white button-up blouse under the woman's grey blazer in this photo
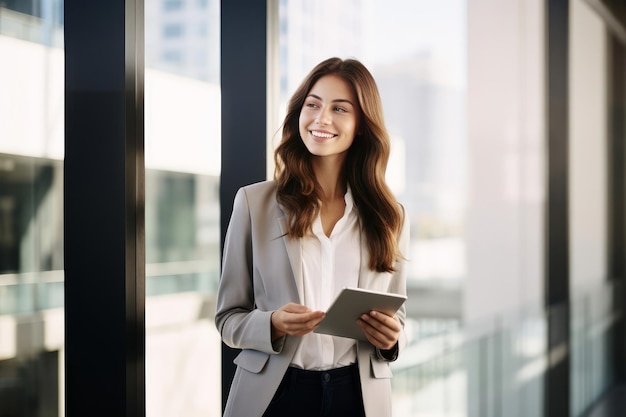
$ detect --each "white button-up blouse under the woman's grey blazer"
[291,187,361,370]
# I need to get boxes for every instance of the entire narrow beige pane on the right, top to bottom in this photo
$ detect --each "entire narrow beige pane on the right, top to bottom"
[568,0,608,415]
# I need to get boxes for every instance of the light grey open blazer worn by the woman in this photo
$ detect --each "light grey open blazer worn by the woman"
[215,181,409,417]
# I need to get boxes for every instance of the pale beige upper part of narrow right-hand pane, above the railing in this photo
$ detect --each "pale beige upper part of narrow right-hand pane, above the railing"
[568,0,609,290]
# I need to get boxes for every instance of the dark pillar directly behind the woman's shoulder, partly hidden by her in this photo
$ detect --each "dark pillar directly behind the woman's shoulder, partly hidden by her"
[220,0,267,412]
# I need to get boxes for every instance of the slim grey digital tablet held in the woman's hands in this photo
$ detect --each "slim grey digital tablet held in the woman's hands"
[314,288,406,340]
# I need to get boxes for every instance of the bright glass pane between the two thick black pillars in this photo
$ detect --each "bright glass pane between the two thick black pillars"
[145,0,221,417]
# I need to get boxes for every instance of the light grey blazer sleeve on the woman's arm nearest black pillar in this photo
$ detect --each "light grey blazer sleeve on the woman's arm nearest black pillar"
[215,188,278,353]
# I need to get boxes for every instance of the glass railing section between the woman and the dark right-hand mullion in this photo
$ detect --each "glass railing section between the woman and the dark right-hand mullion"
[392,308,546,417]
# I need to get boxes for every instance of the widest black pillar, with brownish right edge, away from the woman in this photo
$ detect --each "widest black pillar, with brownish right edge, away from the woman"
[64,0,145,417]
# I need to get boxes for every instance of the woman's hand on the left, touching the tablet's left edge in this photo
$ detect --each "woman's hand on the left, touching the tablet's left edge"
[272,303,326,342]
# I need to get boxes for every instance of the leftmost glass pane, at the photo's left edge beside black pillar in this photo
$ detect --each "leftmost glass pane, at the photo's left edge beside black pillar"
[0,0,64,417]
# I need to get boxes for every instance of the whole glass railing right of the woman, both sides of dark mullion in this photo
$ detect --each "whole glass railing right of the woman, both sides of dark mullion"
[392,283,623,417]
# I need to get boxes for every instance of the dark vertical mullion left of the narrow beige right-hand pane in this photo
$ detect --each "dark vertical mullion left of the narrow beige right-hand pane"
[544,0,570,416]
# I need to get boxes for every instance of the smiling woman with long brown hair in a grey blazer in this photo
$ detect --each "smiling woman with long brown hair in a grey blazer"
[215,58,409,417]
